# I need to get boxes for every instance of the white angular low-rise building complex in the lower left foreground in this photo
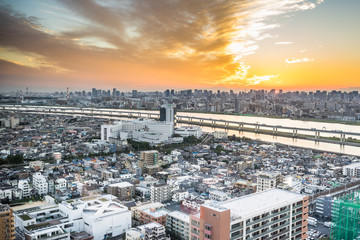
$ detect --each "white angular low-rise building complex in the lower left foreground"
[15,195,131,240]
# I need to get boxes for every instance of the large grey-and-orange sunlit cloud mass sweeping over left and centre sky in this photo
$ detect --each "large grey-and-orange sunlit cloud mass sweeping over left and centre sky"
[0,0,322,86]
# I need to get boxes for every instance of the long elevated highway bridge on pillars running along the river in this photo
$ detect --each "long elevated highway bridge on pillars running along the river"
[0,105,360,146]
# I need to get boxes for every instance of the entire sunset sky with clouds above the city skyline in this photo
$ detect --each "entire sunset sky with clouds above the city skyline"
[0,0,360,91]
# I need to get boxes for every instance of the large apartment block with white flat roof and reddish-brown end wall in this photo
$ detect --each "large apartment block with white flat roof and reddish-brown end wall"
[190,189,309,240]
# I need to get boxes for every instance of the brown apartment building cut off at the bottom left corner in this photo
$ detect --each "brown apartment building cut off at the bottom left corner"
[0,204,15,240]
